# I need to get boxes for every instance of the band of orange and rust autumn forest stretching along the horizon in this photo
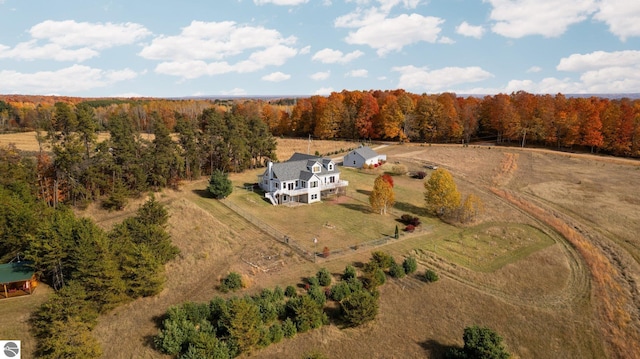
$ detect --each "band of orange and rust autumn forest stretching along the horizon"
[0,90,640,159]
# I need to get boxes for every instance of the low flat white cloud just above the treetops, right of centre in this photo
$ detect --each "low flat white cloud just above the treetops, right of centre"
[392,65,493,92]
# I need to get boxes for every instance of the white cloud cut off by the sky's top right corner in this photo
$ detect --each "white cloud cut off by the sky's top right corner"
[594,0,640,41]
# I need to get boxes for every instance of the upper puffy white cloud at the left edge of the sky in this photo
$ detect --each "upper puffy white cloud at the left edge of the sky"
[0,20,151,62]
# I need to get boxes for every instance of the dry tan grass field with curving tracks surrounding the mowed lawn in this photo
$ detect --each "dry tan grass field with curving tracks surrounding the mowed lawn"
[0,136,640,358]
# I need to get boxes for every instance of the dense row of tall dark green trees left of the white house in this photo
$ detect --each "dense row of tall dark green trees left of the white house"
[31,102,276,209]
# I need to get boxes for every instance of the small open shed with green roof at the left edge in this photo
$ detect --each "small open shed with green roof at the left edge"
[0,261,38,298]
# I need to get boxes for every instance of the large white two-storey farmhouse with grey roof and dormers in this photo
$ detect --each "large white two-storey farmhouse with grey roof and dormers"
[258,153,349,205]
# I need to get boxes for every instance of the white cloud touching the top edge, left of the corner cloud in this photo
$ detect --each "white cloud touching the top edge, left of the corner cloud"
[483,0,598,38]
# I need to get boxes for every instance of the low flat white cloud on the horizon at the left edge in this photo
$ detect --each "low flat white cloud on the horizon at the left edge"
[0,65,138,95]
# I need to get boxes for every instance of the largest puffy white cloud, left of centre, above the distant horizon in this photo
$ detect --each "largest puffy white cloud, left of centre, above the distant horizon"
[139,21,300,79]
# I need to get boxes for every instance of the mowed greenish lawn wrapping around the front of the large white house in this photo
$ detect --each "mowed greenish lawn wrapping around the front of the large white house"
[228,164,555,272]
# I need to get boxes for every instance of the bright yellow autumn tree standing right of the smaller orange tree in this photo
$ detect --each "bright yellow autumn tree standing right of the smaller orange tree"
[424,168,460,217]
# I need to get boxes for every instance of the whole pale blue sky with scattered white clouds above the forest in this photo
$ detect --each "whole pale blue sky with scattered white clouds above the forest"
[0,0,640,97]
